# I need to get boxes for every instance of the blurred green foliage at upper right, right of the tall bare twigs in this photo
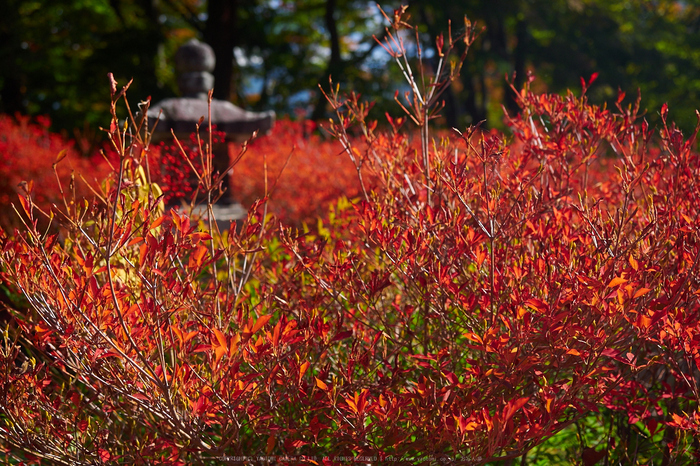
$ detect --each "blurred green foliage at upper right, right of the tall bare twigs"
[392,0,700,131]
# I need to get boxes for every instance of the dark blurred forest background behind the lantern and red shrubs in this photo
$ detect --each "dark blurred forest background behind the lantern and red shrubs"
[0,0,700,145]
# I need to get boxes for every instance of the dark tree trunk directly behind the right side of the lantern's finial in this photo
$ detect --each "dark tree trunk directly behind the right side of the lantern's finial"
[204,0,239,100]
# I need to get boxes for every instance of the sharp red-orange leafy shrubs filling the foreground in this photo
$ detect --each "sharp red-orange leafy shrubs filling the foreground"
[0,10,700,465]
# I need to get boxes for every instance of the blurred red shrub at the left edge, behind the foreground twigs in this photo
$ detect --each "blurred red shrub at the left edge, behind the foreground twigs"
[0,115,109,228]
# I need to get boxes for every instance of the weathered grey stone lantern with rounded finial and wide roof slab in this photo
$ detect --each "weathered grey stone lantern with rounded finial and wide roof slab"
[148,39,275,204]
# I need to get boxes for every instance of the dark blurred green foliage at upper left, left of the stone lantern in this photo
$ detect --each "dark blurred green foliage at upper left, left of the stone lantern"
[0,0,180,135]
